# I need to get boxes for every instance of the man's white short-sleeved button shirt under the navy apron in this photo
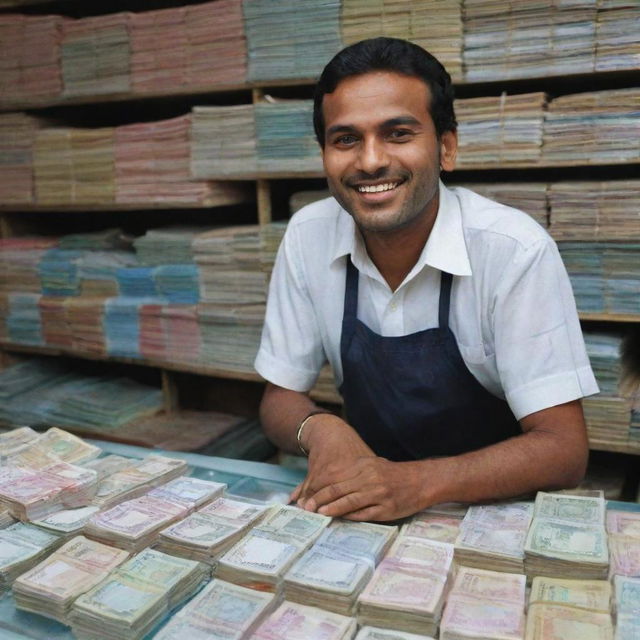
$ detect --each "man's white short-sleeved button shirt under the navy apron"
[255,183,598,420]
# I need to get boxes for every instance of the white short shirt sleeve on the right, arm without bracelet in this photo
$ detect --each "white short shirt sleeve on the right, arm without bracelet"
[493,238,598,420]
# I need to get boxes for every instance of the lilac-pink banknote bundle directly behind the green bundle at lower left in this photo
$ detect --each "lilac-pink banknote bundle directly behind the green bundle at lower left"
[84,495,189,552]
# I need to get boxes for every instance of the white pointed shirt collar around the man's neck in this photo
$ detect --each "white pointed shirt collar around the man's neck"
[332,181,471,279]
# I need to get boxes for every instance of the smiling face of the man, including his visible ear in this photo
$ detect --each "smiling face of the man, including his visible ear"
[322,71,457,233]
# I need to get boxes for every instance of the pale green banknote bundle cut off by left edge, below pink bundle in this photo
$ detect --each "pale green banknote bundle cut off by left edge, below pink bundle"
[0,522,61,594]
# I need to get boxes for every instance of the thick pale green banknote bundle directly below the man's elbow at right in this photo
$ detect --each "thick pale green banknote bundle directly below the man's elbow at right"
[524,491,609,580]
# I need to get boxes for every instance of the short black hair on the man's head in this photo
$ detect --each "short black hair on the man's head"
[313,38,458,147]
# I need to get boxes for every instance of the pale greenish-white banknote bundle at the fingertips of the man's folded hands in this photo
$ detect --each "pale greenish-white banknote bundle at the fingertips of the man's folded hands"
[216,505,331,593]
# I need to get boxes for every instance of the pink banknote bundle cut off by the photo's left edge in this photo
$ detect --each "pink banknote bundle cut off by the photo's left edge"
[0,462,98,521]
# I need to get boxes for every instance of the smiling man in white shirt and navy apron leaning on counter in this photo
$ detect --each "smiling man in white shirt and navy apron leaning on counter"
[256,38,598,520]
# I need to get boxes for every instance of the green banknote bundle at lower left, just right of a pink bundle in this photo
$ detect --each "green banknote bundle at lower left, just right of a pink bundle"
[69,549,209,640]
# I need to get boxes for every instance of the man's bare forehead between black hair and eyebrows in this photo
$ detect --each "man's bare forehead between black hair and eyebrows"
[322,71,431,129]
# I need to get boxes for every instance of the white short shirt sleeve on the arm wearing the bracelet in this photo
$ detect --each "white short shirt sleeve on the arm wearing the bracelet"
[254,225,326,392]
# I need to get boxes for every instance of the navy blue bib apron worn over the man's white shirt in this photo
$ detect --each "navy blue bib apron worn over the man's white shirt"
[340,257,522,461]
